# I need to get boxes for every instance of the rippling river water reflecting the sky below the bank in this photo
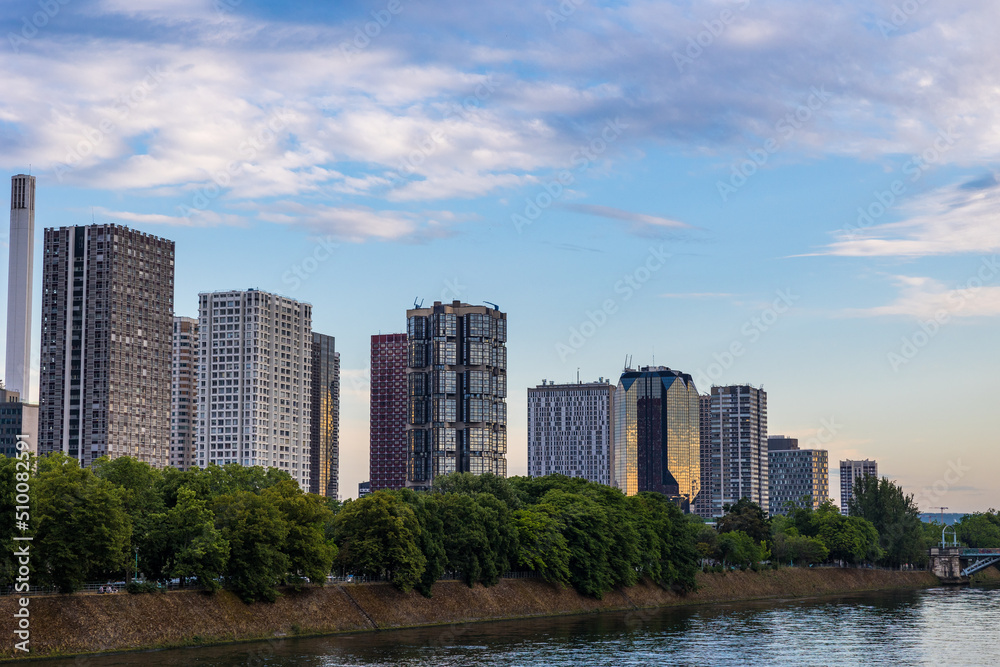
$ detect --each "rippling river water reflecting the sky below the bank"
[23,588,1000,667]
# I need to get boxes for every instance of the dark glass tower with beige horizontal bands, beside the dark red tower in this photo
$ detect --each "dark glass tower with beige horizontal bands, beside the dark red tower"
[406,301,507,488]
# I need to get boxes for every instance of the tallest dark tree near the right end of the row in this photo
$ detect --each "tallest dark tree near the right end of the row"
[848,475,927,567]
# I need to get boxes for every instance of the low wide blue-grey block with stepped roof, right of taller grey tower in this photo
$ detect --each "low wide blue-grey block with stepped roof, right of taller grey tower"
[767,435,830,516]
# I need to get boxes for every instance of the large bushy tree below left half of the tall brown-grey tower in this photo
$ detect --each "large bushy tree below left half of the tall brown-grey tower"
[33,454,132,593]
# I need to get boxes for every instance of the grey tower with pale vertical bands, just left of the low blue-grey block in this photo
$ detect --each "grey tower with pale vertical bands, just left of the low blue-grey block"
[710,385,769,517]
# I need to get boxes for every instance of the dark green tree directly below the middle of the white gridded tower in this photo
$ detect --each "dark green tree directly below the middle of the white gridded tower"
[212,491,289,602]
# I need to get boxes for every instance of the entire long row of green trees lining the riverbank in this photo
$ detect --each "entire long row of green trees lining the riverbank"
[0,454,984,600]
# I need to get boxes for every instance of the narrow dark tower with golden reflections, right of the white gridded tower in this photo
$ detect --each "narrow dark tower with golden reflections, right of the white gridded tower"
[309,331,340,498]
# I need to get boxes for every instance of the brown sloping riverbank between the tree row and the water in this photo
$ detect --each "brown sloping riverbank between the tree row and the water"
[0,568,952,659]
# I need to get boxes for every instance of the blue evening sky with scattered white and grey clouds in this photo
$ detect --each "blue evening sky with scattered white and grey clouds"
[0,0,1000,512]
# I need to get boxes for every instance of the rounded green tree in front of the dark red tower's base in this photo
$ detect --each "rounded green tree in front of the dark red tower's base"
[334,491,427,591]
